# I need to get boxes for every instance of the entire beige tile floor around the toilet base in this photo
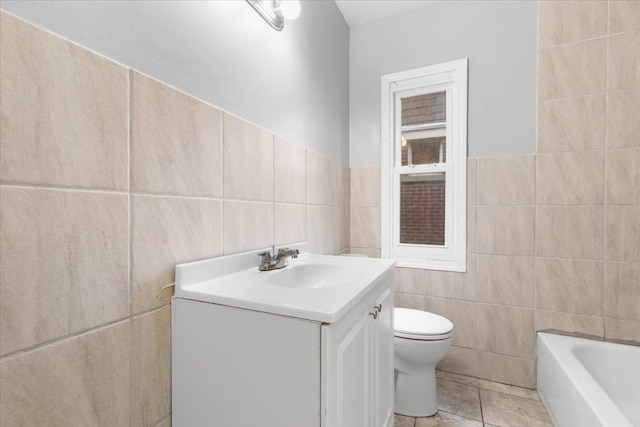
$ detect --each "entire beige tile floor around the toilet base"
[395,371,553,427]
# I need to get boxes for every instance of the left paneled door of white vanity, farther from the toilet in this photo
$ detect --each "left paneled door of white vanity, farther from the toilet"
[321,304,373,427]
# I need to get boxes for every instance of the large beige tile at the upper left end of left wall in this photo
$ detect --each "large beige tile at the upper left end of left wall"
[0,9,129,190]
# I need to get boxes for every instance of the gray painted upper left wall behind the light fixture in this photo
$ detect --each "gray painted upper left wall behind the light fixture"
[2,0,349,163]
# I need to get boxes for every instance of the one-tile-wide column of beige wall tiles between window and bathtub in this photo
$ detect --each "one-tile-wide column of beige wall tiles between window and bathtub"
[467,155,536,387]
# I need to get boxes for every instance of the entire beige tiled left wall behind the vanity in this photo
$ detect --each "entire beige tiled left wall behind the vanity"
[0,12,350,426]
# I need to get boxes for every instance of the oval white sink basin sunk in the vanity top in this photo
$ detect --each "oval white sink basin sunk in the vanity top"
[269,264,360,289]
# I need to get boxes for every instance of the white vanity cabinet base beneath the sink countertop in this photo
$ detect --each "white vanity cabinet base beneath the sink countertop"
[172,257,393,427]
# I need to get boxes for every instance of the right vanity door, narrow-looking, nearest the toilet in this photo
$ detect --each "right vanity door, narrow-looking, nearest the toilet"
[371,289,394,427]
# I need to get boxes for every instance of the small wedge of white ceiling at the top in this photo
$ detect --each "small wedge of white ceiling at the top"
[335,0,434,27]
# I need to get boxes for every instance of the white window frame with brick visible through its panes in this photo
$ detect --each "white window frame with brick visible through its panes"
[381,58,468,272]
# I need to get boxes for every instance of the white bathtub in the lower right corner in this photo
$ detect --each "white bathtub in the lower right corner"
[537,333,640,427]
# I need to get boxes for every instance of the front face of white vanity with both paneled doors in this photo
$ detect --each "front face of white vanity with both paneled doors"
[321,283,393,427]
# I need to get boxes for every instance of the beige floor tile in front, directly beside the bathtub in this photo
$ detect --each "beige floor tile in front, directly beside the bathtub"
[480,389,552,427]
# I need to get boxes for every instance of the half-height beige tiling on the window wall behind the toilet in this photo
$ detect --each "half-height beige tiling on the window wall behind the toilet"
[351,155,536,387]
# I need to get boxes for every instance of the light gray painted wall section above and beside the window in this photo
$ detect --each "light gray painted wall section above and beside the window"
[350,1,537,166]
